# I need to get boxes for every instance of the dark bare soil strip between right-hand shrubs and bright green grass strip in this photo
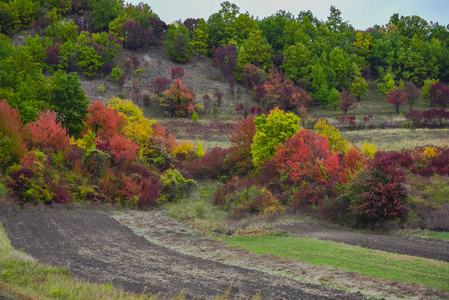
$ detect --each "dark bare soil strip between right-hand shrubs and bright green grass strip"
[277,222,449,262]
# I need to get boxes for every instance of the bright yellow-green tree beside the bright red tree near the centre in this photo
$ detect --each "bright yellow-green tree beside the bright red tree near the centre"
[251,109,300,166]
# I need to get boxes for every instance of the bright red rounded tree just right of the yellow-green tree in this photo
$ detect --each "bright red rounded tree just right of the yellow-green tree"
[274,130,339,184]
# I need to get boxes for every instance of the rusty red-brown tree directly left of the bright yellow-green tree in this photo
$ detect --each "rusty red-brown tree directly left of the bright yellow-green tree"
[228,115,256,175]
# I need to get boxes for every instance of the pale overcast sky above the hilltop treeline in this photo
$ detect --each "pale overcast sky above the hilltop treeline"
[131,0,449,30]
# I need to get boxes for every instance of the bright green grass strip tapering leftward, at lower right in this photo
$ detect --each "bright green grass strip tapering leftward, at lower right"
[222,236,449,291]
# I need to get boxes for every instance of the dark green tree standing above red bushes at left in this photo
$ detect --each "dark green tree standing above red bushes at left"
[49,70,89,138]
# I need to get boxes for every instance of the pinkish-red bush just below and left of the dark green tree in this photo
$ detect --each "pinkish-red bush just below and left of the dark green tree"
[26,110,70,151]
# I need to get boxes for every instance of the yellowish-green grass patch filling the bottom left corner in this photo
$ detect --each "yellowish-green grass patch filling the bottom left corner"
[0,223,180,299]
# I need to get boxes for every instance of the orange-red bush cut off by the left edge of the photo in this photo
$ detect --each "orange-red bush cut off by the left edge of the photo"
[0,100,26,157]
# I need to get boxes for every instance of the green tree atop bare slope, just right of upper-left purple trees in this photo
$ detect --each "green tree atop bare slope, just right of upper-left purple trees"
[165,25,192,62]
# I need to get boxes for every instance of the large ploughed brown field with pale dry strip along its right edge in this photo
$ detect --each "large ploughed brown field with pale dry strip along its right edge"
[4,212,362,299]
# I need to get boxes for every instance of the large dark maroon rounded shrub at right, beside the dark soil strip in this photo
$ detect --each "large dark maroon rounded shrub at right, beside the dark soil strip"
[347,153,408,225]
